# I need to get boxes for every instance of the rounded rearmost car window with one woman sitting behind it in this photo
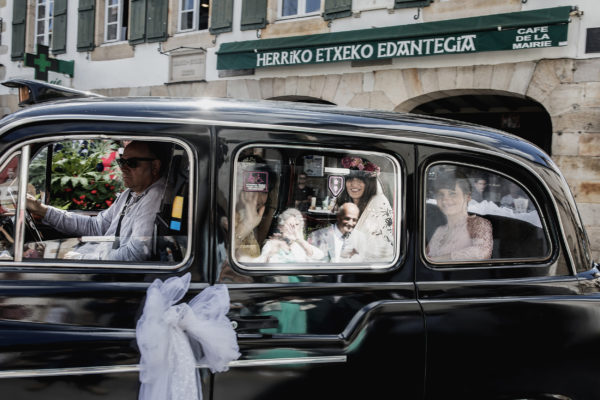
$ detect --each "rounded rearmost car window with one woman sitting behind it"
[424,164,550,264]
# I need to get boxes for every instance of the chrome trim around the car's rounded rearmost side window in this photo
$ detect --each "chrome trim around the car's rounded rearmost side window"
[419,160,554,271]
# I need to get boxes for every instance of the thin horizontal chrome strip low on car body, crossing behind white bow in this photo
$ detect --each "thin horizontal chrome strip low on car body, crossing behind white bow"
[0,355,348,379]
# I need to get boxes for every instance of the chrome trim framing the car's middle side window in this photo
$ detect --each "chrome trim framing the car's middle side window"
[228,142,404,272]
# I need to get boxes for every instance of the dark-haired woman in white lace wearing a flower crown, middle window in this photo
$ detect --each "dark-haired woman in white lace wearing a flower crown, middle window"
[336,157,394,261]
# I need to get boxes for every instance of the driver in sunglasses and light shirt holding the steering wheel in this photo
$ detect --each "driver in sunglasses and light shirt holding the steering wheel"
[27,141,166,261]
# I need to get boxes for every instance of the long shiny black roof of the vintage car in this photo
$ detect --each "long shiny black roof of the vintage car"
[0,97,557,170]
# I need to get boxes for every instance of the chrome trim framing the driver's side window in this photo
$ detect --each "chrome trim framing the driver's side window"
[0,133,196,271]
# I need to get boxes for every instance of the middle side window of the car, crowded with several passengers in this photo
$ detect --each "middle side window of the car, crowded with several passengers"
[233,147,399,269]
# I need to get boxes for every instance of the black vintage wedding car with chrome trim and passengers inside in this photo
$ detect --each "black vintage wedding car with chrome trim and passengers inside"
[0,79,600,400]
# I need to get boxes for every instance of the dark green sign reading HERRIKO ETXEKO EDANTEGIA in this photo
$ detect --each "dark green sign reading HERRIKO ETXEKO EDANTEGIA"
[217,7,572,70]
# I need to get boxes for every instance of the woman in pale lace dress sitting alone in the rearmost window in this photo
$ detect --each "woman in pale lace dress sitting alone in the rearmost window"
[426,172,493,261]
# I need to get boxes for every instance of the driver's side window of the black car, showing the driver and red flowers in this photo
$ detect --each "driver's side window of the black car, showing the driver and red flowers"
[0,138,191,267]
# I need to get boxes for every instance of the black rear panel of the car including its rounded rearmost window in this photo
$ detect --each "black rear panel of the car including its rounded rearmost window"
[416,146,598,399]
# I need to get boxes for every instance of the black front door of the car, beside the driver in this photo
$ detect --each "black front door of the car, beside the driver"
[0,121,210,399]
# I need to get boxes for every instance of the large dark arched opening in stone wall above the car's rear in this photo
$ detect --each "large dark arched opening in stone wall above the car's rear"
[412,91,552,154]
